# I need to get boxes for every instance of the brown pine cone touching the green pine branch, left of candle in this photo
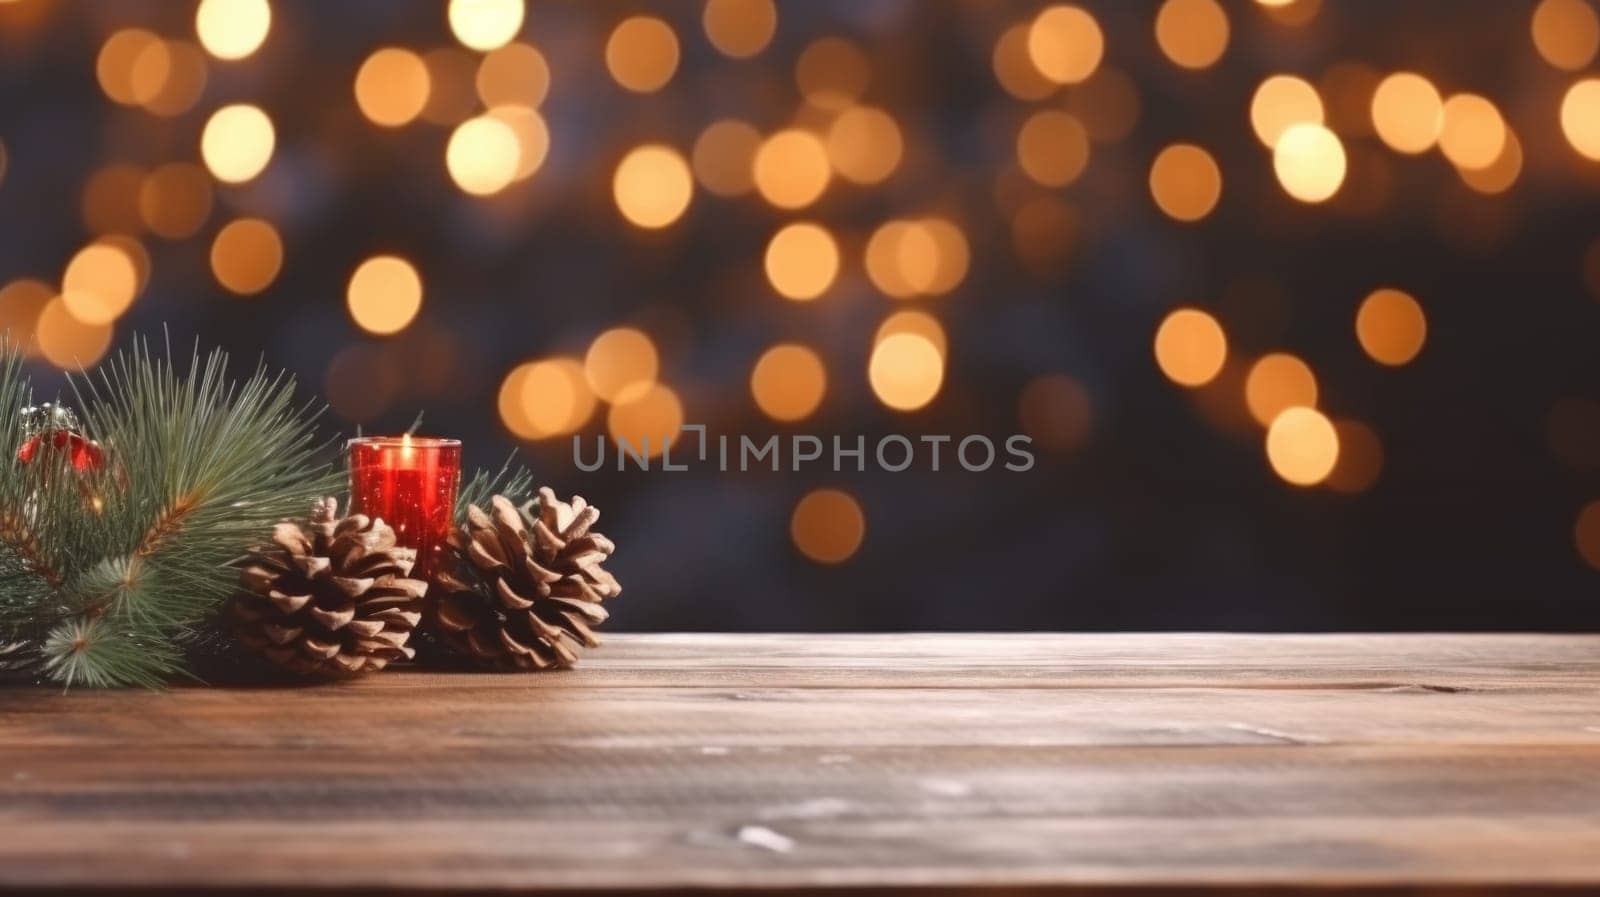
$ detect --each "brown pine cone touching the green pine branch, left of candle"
[232,499,427,675]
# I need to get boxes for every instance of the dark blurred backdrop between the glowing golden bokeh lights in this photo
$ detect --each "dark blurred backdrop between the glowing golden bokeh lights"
[0,0,1600,630]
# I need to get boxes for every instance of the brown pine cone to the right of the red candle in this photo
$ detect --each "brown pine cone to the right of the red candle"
[432,488,622,670]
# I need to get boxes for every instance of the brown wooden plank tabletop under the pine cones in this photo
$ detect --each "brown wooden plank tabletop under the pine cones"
[0,635,1600,894]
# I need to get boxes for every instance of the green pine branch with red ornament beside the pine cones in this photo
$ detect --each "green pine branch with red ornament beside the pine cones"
[0,341,338,686]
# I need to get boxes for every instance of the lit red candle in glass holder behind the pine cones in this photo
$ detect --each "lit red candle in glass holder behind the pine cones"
[350,433,461,579]
